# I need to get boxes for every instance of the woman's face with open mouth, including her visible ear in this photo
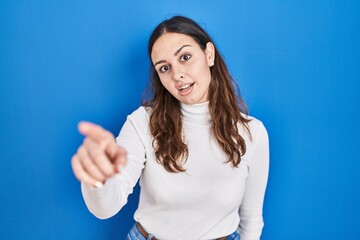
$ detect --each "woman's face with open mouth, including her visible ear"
[151,33,215,104]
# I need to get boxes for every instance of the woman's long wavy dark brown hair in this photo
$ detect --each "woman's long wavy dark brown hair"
[143,16,251,172]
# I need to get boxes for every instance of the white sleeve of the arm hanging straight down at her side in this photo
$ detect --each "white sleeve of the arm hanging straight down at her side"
[238,123,269,240]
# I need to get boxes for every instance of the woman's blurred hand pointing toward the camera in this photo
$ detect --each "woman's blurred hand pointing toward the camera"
[71,122,127,188]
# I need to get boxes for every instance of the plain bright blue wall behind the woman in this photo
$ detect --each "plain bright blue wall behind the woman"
[0,0,360,240]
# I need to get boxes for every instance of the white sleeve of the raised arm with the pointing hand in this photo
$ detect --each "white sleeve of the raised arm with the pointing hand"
[81,111,146,219]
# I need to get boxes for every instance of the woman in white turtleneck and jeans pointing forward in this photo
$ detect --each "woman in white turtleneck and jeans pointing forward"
[72,16,269,240]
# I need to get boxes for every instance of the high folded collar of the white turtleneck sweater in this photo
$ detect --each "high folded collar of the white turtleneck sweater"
[181,101,211,125]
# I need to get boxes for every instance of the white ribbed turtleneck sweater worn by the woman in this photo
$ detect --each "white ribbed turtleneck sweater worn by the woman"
[82,102,269,240]
